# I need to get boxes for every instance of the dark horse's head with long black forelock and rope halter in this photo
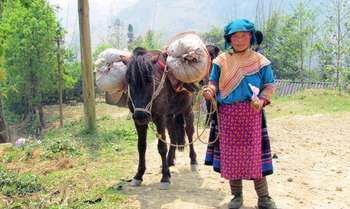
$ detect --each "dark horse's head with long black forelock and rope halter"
[126,48,165,125]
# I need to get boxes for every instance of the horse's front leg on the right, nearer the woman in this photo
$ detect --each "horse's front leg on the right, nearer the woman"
[154,117,170,190]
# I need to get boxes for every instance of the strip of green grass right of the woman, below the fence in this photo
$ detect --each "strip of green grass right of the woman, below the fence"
[266,90,350,118]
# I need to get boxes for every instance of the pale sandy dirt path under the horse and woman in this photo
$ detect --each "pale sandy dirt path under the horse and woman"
[125,113,350,209]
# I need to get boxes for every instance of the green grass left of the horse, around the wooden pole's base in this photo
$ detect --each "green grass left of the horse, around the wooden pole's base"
[0,112,149,208]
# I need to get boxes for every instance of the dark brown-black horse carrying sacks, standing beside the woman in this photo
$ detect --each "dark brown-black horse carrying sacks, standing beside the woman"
[126,48,197,189]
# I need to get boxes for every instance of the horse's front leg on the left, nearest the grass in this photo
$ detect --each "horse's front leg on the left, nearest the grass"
[131,123,148,186]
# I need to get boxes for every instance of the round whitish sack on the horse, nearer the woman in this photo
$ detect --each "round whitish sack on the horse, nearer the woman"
[166,32,210,83]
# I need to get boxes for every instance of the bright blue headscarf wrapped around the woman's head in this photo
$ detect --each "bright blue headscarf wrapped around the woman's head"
[224,19,256,49]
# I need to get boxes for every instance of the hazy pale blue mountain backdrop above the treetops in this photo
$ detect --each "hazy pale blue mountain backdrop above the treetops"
[49,0,329,48]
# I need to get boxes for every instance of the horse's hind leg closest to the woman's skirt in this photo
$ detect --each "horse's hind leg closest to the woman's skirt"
[184,107,198,171]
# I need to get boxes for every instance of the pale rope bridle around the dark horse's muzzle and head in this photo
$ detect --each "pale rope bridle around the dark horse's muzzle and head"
[128,66,168,116]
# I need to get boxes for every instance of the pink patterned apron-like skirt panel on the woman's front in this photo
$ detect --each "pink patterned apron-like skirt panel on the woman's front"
[219,102,262,180]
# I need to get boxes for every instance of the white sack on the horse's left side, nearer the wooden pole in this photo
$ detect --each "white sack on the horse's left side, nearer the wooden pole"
[95,48,130,92]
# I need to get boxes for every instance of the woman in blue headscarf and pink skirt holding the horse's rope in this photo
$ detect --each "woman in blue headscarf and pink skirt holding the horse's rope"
[203,19,276,209]
